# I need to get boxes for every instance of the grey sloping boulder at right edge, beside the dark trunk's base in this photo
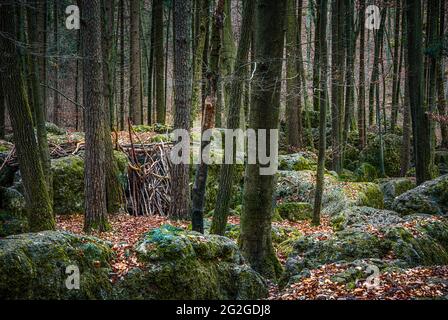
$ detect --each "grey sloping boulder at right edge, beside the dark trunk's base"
[392,175,448,215]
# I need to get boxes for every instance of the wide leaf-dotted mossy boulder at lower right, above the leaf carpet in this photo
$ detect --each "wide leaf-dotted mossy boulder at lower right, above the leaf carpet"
[282,212,448,283]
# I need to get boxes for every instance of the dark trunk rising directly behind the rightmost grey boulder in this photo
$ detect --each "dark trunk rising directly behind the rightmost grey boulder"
[406,0,432,184]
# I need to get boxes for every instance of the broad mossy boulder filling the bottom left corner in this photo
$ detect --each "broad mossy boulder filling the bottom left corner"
[0,231,112,300]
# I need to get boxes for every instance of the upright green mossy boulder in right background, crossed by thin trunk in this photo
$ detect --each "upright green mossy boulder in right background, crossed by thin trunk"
[360,134,402,177]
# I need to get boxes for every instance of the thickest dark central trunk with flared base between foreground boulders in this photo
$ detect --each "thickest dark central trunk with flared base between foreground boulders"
[240,0,286,278]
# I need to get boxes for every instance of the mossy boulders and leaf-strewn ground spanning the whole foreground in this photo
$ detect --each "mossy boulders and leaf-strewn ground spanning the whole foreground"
[0,127,448,300]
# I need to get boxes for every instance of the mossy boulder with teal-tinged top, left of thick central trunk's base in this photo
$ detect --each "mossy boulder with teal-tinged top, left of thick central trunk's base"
[115,226,267,300]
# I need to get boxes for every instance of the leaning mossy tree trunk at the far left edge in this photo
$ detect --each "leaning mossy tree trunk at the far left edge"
[0,2,55,232]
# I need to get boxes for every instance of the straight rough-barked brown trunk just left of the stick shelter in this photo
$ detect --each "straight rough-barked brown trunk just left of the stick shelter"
[79,0,109,232]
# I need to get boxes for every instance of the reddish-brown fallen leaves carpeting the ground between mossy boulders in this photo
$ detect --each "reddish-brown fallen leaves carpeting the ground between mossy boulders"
[57,214,448,300]
